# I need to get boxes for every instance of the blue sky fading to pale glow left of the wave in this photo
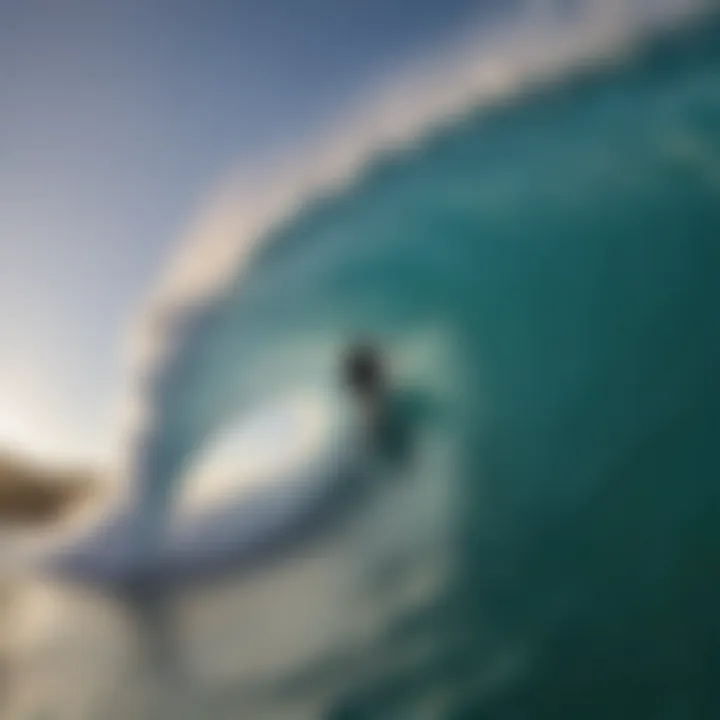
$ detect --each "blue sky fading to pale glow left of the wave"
[0,0,496,462]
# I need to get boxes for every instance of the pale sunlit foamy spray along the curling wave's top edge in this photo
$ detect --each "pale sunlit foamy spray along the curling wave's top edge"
[136,0,712,312]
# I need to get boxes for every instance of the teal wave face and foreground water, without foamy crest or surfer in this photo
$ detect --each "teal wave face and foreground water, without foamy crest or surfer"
[2,7,720,720]
